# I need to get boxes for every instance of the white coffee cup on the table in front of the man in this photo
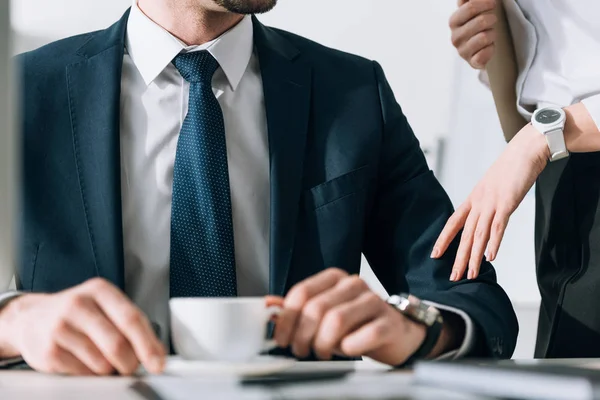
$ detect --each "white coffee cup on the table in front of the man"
[169,297,281,361]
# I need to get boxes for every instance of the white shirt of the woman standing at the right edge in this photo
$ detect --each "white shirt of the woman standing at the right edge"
[504,0,600,128]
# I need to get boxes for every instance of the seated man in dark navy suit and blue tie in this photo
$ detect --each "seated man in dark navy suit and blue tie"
[0,0,518,374]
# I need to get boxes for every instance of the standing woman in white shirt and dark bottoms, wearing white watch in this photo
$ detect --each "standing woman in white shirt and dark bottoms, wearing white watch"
[432,0,600,358]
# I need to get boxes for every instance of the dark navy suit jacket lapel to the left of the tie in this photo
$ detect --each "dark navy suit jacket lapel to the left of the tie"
[67,12,129,288]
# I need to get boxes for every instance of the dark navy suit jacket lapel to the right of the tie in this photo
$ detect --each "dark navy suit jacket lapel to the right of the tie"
[254,18,312,295]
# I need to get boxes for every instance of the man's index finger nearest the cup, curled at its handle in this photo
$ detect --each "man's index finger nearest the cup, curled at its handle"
[275,268,348,347]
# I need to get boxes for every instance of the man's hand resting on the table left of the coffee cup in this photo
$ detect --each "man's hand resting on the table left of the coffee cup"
[0,278,165,375]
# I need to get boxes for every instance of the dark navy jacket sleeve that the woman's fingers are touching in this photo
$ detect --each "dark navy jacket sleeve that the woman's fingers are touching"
[364,63,518,358]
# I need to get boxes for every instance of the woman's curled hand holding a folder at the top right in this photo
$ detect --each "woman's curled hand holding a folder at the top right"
[450,0,502,69]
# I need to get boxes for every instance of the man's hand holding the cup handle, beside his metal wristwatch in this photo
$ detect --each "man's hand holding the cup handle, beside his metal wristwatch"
[267,268,462,365]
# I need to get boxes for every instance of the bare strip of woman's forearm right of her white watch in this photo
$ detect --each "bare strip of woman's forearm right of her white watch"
[564,103,600,153]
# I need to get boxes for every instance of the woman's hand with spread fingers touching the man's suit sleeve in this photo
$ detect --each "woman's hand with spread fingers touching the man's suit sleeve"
[431,124,550,281]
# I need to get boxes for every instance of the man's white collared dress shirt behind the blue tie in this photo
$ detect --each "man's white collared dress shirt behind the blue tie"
[121,3,270,340]
